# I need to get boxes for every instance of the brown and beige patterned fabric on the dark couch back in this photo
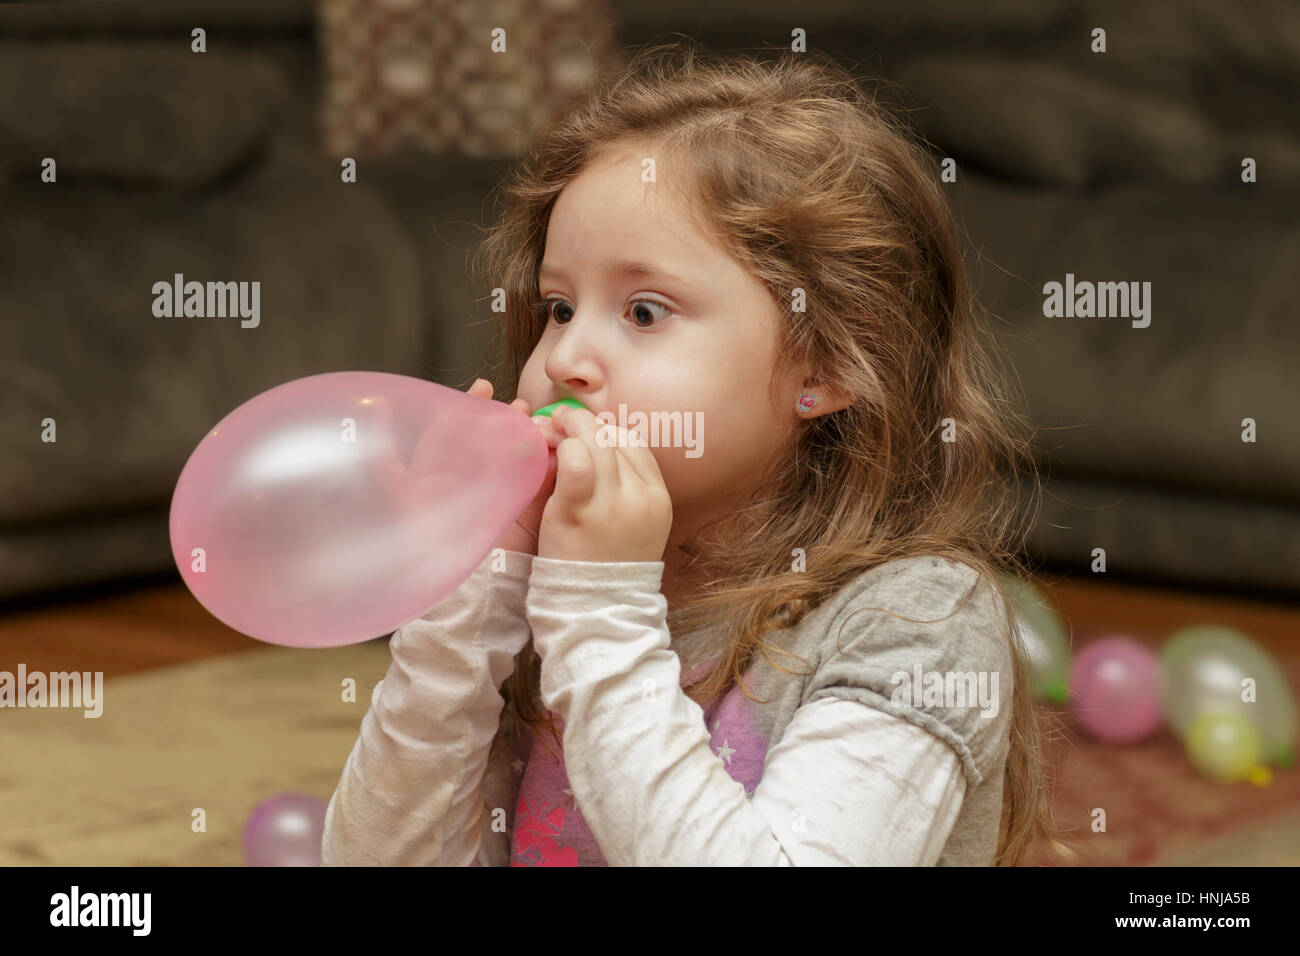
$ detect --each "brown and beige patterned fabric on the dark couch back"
[319,0,618,156]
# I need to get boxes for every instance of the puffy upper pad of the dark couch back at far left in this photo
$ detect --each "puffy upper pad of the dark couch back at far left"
[0,40,289,187]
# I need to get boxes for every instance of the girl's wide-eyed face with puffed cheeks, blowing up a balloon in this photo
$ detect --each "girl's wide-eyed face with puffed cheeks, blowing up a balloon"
[519,147,800,528]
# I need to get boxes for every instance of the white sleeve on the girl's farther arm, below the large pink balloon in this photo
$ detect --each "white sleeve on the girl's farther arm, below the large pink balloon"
[321,549,533,866]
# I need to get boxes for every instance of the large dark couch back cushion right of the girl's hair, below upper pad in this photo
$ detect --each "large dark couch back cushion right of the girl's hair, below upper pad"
[950,176,1300,507]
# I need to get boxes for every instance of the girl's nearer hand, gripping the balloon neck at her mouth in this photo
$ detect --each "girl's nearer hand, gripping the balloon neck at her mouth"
[537,406,672,562]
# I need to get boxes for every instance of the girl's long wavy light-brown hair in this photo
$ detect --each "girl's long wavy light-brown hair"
[475,42,1075,865]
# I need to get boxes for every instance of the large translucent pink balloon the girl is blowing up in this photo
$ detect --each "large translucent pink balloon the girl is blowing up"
[170,372,547,648]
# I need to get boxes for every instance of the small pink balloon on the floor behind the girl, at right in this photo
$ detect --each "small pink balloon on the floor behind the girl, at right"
[1070,636,1164,744]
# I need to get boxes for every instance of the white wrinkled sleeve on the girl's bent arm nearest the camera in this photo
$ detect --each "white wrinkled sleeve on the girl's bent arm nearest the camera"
[527,558,966,866]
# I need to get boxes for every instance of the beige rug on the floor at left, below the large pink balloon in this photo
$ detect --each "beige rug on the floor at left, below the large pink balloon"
[0,640,390,866]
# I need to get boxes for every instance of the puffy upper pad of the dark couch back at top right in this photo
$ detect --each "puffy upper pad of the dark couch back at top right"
[897,56,1300,189]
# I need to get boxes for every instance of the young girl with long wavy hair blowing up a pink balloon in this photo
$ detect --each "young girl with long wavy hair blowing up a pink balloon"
[322,46,1066,866]
